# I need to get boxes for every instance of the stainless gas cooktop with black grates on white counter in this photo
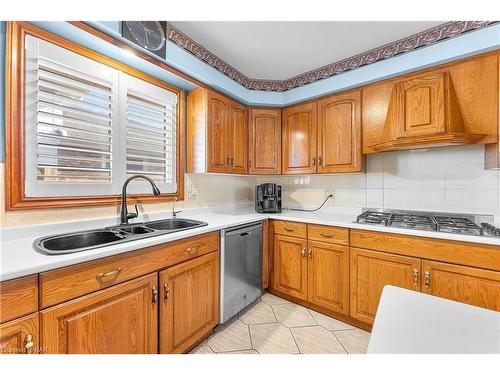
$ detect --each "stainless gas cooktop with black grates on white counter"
[356,208,500,237]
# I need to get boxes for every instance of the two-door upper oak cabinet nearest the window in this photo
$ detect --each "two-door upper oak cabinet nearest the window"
[186,88,248,174]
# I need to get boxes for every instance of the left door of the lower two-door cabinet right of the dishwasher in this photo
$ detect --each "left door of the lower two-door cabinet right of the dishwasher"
[273,235,307,300]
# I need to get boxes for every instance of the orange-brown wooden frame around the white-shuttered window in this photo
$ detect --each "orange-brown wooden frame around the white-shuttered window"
[5,21,185,211]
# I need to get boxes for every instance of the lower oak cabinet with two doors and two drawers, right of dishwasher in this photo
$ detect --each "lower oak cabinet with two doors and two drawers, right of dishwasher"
[272,220,349,315]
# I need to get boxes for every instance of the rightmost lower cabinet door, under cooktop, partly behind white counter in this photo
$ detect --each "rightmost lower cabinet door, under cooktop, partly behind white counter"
[422,260,500,311]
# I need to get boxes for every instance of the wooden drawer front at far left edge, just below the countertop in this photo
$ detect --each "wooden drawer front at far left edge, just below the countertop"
[0,275,38,323]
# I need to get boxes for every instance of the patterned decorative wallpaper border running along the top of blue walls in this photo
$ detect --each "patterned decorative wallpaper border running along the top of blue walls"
[167,21,497,91]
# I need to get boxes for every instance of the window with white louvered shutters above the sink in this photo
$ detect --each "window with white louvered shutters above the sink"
[6,23,183,208]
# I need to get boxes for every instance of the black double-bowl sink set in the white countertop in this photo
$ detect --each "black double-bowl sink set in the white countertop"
[33,218,208,255]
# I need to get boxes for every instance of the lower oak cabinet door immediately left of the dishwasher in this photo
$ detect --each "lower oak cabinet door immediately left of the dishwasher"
[160,251,219,353]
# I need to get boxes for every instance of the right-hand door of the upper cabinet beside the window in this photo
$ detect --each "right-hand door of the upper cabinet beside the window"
[229,101,248,174]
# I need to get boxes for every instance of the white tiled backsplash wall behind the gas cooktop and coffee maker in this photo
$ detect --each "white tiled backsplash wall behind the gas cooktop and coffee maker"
[255,145,500,223]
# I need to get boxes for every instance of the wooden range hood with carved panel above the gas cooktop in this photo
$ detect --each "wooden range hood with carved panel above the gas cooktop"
[370,71,487,152]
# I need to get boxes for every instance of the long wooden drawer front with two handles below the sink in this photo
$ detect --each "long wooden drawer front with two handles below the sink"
[40,232,219,308]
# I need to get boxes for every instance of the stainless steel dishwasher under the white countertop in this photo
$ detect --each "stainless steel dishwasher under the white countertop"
[220,222,262,323]
